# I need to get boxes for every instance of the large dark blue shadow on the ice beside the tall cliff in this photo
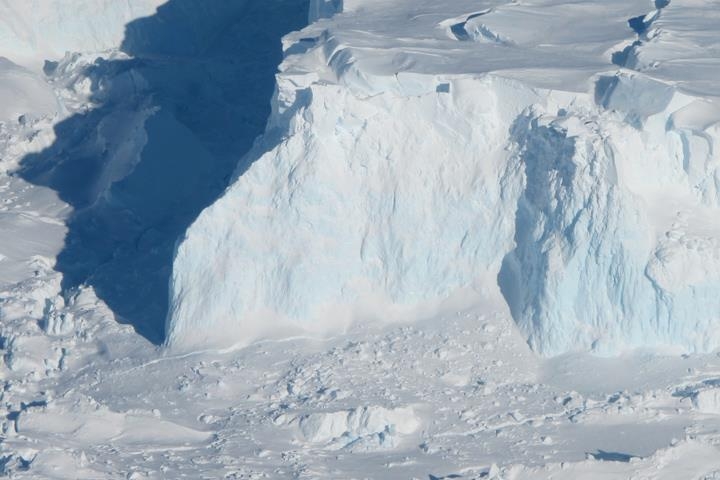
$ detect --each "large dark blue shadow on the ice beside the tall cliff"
[19,0,308,344]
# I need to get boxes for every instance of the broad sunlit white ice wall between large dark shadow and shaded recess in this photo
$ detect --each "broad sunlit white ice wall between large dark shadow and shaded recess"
[168,79,532,347]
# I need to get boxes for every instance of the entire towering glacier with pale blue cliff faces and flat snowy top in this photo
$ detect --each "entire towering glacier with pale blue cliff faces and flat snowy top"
[167,0,720,355]
